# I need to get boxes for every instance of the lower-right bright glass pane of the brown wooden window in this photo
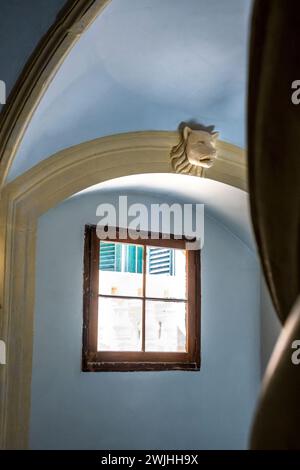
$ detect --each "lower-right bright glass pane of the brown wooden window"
[145,300,186,352]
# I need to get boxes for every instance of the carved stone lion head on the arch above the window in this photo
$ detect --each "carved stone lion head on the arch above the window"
[170,126,219,176]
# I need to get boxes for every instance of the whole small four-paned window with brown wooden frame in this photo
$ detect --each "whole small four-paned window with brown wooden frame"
[82,225,200,371]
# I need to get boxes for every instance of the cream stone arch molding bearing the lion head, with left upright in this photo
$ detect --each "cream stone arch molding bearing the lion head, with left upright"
[0,132,246,449]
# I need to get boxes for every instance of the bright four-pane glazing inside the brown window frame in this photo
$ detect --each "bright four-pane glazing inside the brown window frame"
[98,242,187,352]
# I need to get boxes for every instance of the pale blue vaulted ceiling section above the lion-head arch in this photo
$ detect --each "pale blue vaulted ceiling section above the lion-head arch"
[9,0,251,180]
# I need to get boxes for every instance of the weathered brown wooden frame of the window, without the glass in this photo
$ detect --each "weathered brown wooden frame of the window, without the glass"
[82,225,201,372]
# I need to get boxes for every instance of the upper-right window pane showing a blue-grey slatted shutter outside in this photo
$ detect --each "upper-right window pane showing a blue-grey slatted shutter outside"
[146,247,186,299]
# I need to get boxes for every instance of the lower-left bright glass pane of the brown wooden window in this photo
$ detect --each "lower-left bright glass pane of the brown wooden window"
[98,297,142,351]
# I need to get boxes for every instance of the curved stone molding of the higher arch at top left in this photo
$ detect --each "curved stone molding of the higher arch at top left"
[0,0,111,188]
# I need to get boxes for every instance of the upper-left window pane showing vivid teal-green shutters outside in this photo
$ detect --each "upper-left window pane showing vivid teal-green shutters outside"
[99,241,143,297]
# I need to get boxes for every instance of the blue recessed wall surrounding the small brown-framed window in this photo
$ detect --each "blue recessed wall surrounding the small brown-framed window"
[30,190,260,449]
